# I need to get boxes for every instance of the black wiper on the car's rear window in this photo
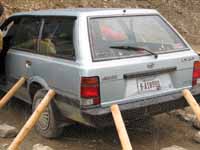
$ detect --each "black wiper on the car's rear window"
[110,46,158,58]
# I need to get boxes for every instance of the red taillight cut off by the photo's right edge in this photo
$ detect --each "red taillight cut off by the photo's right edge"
[192,61,200,86]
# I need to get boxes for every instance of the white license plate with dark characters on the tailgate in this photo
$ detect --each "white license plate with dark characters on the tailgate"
[137,79,161,92]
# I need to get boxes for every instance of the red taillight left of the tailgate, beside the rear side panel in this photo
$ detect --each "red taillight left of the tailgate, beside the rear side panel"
[80,77,100,106]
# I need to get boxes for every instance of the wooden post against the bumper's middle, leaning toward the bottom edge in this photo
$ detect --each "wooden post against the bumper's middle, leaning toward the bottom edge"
[111,104,133,150]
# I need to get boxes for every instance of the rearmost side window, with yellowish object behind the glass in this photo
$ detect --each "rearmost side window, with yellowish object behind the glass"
[39,17,75,59]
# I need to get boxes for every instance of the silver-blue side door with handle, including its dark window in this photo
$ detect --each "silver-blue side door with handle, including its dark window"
[5,17,41,100]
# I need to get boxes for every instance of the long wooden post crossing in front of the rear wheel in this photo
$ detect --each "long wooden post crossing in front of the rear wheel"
[8,90,56,150]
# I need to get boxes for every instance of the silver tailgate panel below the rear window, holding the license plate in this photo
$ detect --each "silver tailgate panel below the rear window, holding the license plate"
[88,51,198,106]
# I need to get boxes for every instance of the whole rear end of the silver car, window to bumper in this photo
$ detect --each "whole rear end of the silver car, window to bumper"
[77,9,200,126]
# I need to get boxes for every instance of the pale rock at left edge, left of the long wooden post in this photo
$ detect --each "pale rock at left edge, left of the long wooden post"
[0,124,18,138]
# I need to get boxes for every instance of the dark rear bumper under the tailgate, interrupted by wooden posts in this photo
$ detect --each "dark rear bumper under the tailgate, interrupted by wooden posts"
[81,86,200,127]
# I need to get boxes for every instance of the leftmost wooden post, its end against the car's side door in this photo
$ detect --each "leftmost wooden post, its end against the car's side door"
[0,77,26,109]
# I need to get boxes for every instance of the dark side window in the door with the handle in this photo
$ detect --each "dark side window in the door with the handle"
[12,17,41,52]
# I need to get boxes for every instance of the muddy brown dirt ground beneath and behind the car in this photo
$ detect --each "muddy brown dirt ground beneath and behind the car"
[0,95,200,150]
